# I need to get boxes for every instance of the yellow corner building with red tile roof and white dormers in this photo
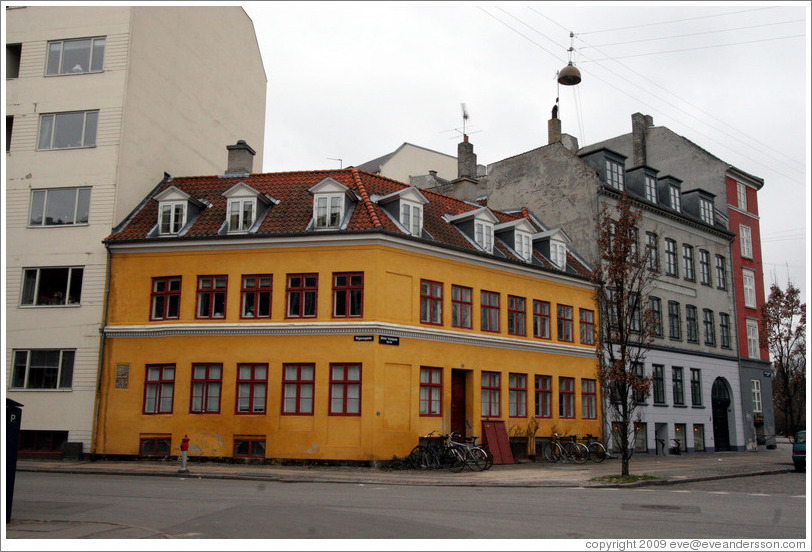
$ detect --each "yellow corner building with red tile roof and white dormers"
[94,146,601,461]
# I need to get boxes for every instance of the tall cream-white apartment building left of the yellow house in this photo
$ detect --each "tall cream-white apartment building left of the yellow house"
[3,6,267,455]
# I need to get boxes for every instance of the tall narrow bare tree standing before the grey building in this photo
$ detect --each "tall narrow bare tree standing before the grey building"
[592,193,661,475]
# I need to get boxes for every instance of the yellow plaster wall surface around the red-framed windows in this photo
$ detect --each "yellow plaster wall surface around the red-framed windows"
[96,245,601,460]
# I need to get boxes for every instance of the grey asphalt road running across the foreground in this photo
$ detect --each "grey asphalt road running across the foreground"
[7,472,806,539]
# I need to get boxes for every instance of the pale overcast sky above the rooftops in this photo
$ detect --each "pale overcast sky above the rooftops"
[242,2,810,302]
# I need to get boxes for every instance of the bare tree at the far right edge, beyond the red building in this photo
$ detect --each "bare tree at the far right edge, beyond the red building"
[759,282,806,435]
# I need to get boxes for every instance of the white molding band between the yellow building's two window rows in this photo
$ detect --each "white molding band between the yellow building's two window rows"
[101,322,596,358]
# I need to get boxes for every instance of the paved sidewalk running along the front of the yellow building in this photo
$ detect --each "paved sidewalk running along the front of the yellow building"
[12,442,793,487]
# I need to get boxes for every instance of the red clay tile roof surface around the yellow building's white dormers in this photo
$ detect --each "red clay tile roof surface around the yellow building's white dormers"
[105,168,588,276]
